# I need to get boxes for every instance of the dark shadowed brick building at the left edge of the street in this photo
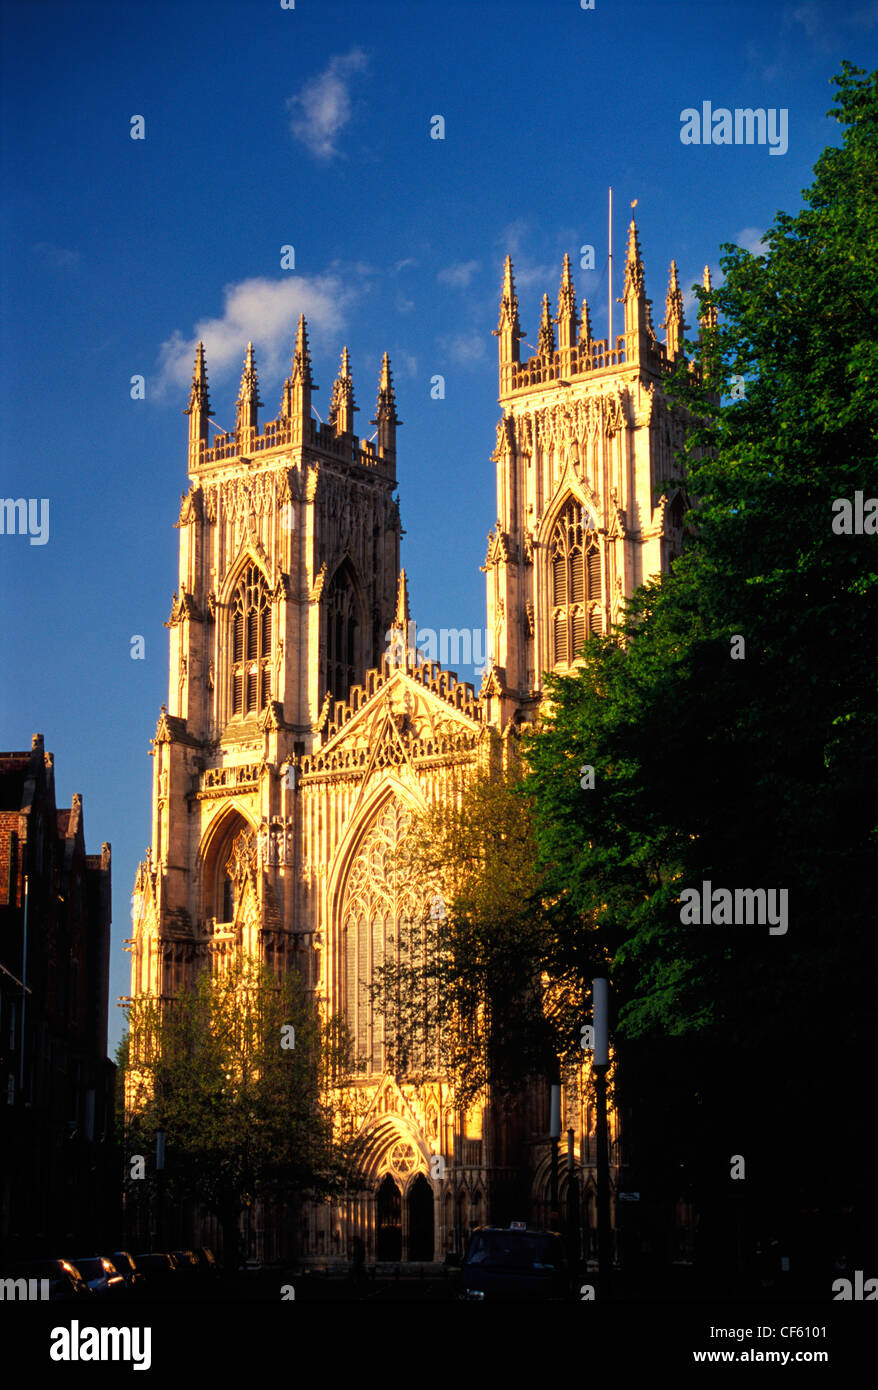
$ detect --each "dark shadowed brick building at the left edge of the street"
[0,734,118,1258]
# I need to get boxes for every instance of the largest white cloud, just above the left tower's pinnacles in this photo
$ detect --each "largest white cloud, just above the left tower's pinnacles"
[157,274,356,395]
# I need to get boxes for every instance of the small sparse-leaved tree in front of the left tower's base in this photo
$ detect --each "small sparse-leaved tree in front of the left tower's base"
[118,962,353,1262]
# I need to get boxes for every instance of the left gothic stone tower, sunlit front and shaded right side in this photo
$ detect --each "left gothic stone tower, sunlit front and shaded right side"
[132,325,400,995]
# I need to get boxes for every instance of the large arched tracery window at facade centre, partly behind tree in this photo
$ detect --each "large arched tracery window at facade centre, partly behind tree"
[342,801,426,1073]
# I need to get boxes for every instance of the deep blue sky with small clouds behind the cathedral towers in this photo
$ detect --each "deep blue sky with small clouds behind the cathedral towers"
[0,0,878,1043]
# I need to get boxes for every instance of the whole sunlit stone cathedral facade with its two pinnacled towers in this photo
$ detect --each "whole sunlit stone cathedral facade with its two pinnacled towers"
[129,221,707,1264]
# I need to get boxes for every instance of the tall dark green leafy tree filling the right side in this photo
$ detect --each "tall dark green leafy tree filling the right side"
[527,63,878,1273]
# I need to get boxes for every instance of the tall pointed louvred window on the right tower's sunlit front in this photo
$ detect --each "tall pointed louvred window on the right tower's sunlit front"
[549,499,602,666]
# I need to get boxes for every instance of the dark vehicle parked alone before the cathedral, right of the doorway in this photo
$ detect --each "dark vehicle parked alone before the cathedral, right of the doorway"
[458,1225,571,1301]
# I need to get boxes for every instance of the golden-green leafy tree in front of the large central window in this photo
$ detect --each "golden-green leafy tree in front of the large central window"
[372,773,582,1109]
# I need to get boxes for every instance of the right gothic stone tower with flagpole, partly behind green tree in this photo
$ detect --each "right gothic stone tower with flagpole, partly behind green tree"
[485,220,684,723]
